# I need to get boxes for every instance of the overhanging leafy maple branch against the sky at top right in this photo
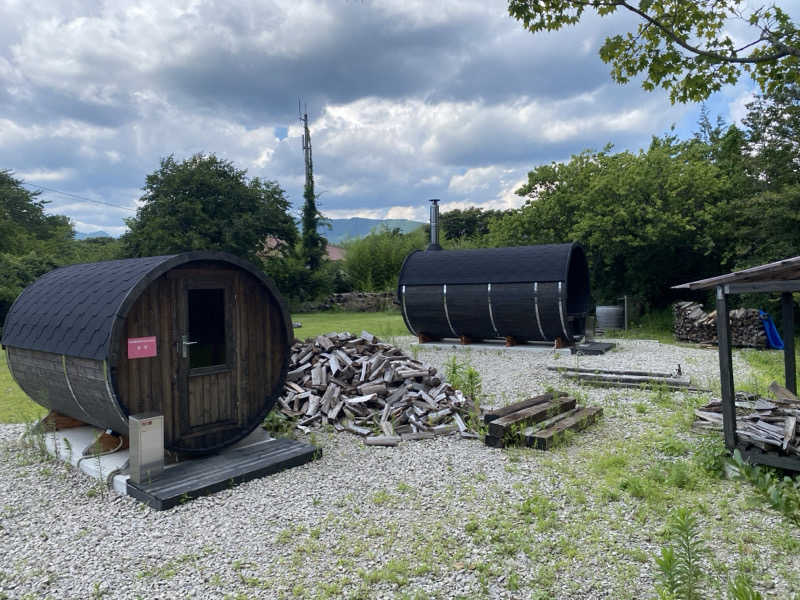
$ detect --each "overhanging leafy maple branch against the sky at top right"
[508,0,800,103]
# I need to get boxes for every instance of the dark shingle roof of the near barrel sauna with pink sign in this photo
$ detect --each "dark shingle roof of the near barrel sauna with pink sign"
[2,256,175,360]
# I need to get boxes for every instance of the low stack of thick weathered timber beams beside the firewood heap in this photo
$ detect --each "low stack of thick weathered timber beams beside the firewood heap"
[483,392,603,450]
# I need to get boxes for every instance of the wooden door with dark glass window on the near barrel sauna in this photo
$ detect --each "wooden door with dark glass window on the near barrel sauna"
[176,273,239,442]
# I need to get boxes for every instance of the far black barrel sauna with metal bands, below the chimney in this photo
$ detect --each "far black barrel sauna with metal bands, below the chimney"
[398,244,590,343]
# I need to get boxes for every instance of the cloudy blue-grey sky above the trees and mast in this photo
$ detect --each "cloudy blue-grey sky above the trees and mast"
[0,0,764,235]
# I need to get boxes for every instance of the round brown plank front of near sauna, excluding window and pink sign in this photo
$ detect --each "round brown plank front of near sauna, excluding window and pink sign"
[116,267,290,450]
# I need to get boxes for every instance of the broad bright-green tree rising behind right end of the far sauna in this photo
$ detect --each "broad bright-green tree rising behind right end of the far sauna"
[489,136,738,306]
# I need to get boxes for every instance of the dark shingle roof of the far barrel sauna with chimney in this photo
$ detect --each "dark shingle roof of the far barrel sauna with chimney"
[399,244,576,286]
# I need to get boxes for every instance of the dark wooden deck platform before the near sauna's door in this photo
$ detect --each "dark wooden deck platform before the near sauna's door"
[127,439,322,510]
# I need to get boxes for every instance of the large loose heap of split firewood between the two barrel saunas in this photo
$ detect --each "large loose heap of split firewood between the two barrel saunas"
[278,331,477,446]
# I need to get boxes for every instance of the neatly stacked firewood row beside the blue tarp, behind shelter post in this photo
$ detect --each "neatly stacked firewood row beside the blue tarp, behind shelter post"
[672,302,767,348]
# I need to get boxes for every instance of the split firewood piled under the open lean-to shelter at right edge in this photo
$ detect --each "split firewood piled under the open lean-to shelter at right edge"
[693,382,800,456]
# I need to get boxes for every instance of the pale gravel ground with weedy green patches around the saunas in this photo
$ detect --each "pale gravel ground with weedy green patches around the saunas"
[0,338,800,600]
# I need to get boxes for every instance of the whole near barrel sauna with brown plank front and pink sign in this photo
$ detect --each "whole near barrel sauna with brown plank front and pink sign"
[2,252,293,454]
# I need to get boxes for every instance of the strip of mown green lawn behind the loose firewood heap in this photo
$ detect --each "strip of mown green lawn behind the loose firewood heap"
[292,312,411,339]
